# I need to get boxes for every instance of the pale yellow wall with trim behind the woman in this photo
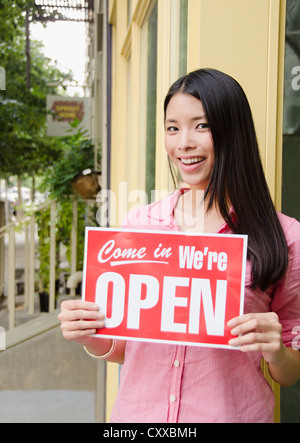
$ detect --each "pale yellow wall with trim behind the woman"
[109,0,286,424]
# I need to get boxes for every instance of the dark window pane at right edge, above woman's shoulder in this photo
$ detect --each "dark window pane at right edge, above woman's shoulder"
[282,0,300,220]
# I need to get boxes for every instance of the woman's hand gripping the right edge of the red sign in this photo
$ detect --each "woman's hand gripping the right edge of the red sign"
[227,312,286,364]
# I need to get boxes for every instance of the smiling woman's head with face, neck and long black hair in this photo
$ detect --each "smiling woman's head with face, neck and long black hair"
[164,69,288,290]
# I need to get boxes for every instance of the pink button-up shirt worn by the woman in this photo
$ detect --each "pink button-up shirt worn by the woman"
[111,191,300,423]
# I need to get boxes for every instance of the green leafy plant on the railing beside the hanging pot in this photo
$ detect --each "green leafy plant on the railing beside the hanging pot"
[37,120,100,300]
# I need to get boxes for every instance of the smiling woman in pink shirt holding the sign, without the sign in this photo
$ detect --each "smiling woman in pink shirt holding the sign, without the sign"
[59,69,300,423]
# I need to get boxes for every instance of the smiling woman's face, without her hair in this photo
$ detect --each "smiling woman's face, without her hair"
[165,93,215,190]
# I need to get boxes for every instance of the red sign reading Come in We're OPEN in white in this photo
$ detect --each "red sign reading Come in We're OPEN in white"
[83,228,247,348]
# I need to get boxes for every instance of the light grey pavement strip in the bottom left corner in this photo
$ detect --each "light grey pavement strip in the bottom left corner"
[0,390,96,423]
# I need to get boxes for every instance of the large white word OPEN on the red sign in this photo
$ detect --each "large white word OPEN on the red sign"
[95,272,229,341]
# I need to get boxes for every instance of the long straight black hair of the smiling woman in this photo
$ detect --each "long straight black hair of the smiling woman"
[164,69,288,291]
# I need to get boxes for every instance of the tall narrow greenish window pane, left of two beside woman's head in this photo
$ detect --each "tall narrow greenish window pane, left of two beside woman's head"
[145,3,157,201]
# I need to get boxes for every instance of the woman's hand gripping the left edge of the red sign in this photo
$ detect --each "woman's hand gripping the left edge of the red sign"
[58,300,105,346]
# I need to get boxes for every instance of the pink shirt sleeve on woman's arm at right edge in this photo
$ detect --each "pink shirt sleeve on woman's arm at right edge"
[271,219,300,346]
